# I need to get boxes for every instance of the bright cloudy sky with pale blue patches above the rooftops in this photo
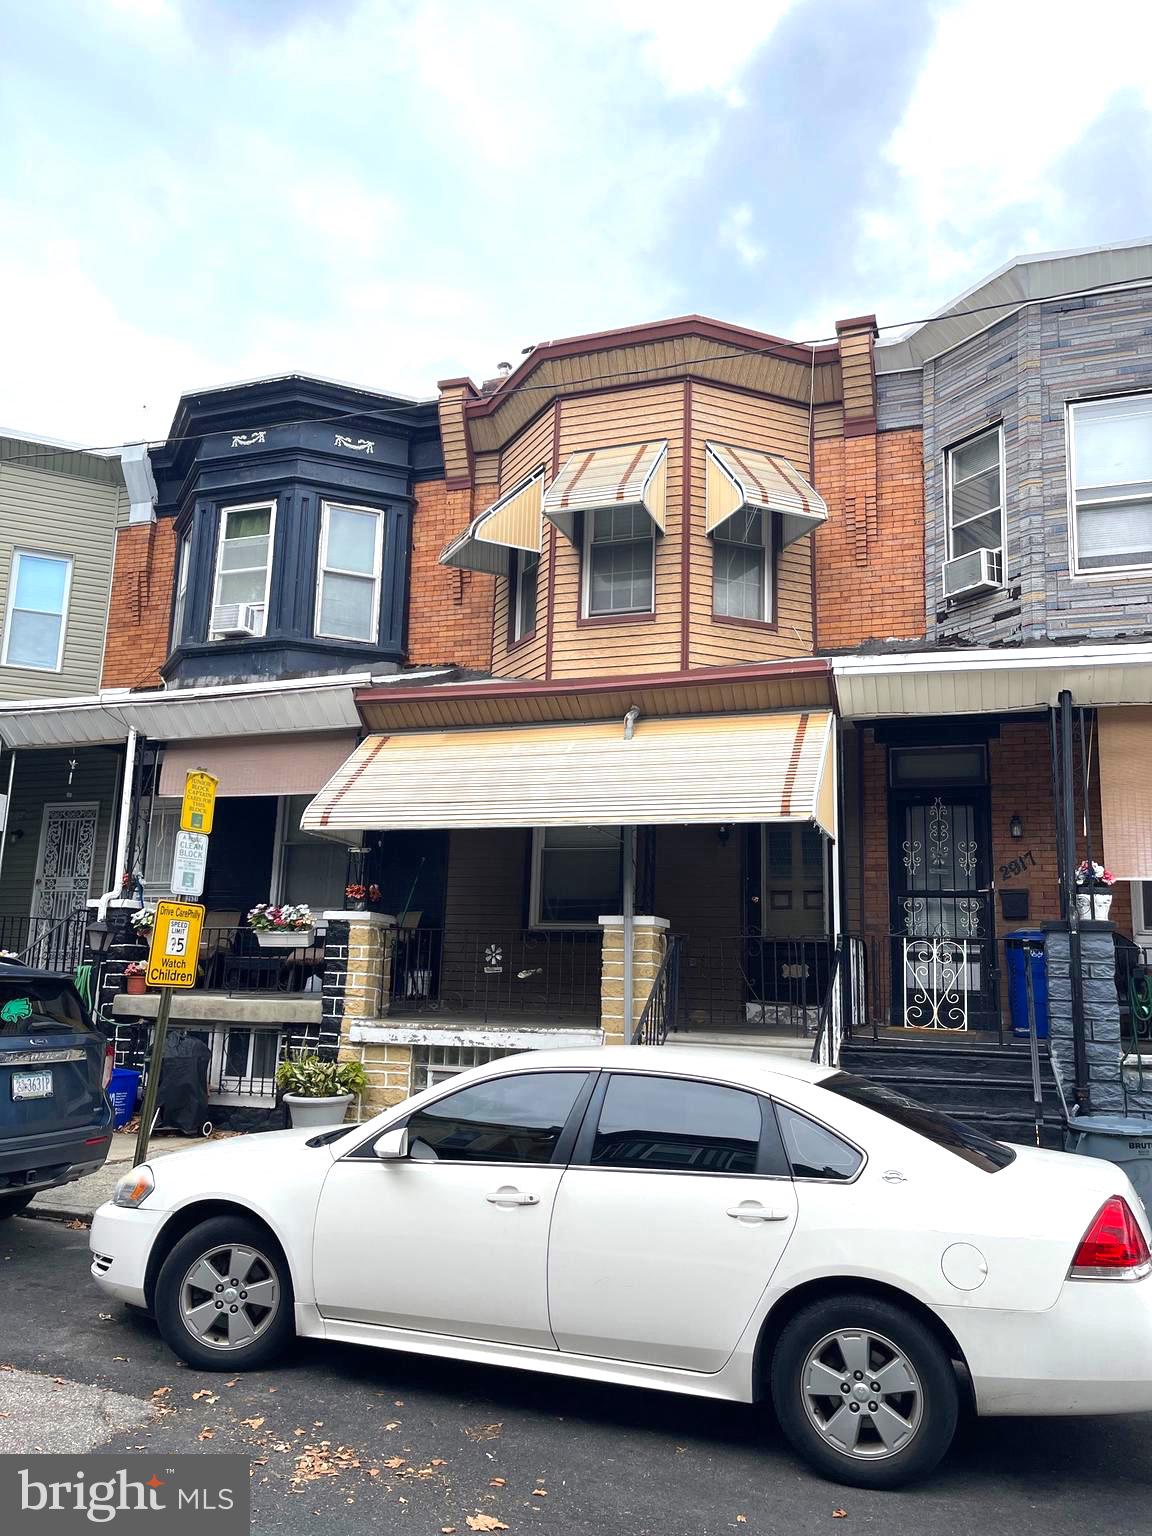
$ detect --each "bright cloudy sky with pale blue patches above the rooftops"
[0,0,1152,445]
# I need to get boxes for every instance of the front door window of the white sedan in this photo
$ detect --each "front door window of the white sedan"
[409,1072,588,1163]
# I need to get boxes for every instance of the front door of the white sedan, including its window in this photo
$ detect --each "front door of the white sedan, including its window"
[313,1071,588,1349]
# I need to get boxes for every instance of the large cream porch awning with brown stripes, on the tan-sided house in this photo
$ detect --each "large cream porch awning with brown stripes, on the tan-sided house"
[300,710,836,837]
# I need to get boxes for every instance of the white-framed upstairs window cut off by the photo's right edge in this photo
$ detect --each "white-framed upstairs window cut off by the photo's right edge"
[1068,395,1152,573]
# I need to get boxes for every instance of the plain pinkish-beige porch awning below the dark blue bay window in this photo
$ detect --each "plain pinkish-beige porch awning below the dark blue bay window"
[160,731,356,799]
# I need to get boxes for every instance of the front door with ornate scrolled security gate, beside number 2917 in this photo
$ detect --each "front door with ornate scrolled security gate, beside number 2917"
[889,786,997,1031]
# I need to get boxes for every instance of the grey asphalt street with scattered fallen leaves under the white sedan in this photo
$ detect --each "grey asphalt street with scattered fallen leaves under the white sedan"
[0,1218,1152,1536]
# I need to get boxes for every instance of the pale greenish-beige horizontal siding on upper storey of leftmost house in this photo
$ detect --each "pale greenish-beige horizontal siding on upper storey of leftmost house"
[0,455,124,700]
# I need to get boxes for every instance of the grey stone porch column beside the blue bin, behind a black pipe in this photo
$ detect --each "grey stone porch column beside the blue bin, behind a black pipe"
[1044,923,1124,1114]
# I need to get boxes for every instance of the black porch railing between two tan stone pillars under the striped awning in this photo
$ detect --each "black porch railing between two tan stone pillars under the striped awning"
[390,926,602,1023]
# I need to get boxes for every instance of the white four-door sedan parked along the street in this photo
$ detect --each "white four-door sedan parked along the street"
[92,1048,1152,1487]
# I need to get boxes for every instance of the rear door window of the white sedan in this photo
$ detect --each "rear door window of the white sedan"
[591,1074,762,1174]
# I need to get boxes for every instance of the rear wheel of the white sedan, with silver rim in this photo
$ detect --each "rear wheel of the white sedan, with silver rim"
[771,1293,960,1488]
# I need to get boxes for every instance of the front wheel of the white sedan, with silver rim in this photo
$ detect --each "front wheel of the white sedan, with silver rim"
[154,1215,295,1372]
